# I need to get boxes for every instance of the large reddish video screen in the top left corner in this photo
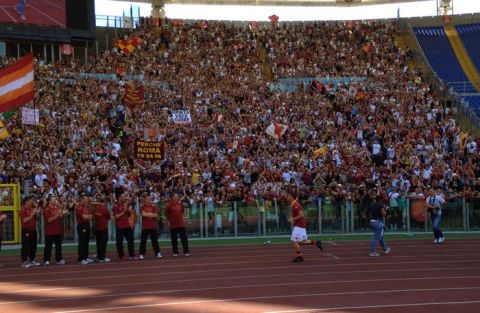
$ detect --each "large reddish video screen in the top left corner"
[0,0,65,28]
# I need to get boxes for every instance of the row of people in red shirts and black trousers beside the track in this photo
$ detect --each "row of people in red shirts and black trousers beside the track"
[16,193,190,268]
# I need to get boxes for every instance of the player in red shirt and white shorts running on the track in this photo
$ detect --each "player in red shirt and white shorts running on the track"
[285,193,323,262]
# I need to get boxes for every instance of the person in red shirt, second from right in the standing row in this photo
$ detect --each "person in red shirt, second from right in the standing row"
[140,196,162,260]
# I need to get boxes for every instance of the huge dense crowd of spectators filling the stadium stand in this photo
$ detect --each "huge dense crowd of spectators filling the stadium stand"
[0,22,480,238]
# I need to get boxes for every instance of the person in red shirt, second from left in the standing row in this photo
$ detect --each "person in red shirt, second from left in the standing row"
[43,196,68,266]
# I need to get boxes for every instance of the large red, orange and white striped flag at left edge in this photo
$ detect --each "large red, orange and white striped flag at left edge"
[0,54,34,113]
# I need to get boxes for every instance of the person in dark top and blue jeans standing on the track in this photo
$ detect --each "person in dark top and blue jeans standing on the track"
[369,195,390,257]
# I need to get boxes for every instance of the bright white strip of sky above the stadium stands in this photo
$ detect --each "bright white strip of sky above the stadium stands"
[95,0,480,21]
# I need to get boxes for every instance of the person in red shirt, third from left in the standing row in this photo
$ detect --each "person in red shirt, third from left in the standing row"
[75,194,93,265]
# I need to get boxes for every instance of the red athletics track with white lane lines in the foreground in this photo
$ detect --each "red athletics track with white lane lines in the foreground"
[0,238,480,313]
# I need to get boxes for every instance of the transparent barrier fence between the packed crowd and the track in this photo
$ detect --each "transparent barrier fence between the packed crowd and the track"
[22,197,480,242]
